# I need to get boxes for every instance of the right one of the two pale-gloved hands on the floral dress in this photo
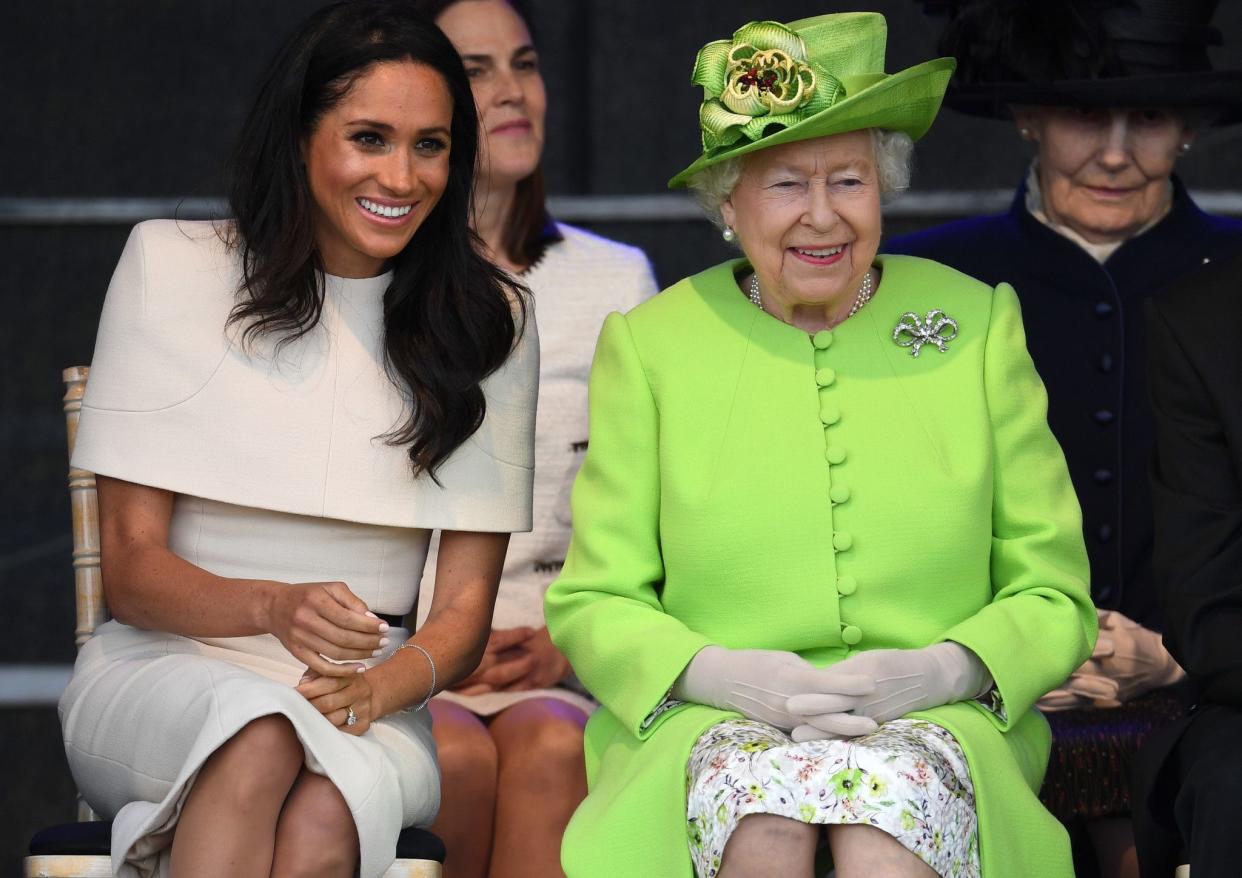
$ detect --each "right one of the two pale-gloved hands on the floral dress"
[785,642,992,741]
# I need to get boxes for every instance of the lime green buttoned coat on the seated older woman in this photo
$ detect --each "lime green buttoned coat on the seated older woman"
[546,250,1097,878]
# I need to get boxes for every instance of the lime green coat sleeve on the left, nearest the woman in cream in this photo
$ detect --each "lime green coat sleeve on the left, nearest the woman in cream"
[545,314,709,738]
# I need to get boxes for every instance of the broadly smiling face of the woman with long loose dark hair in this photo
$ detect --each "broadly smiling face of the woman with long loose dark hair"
[302,61,453,277]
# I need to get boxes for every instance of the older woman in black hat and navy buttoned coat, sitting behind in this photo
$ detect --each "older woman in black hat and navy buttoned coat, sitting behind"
[888,0,1242,876]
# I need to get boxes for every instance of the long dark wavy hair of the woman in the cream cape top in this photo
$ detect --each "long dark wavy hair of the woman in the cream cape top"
[227,0,528,478]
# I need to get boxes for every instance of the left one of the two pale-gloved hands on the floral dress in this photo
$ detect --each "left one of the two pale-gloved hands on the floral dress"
[672,646,877,736]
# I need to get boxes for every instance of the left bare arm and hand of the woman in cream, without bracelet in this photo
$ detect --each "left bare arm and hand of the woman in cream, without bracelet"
[98,476,384,676]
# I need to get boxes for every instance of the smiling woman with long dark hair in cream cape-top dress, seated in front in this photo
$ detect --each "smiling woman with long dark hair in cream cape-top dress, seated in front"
[61,0,538,878]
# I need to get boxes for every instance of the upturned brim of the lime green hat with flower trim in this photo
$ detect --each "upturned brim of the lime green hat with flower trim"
[668,58,956,189]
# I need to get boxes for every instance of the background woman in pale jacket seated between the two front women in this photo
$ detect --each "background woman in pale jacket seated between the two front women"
[417,0,656,878]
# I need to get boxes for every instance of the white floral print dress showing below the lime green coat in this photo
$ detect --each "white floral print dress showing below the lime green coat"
[686,719,979,878]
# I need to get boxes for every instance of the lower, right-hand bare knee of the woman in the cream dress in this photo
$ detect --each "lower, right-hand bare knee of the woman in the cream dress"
[279,771,358,876]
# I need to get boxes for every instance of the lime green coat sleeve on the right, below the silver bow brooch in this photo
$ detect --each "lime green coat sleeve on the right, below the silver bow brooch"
[943,283,1098,729]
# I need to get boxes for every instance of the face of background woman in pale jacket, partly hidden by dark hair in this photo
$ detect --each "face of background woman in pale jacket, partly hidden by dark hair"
[436,0,548,189]
